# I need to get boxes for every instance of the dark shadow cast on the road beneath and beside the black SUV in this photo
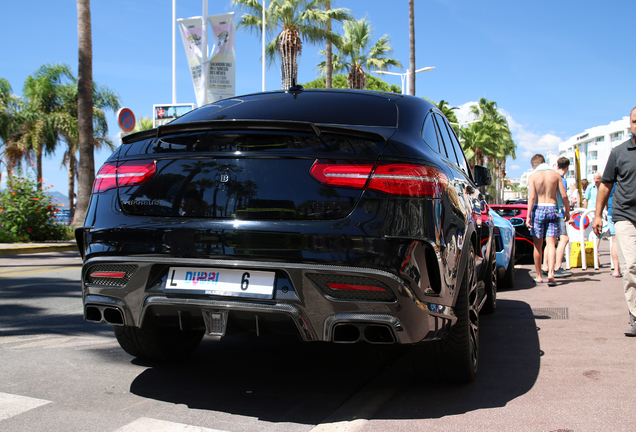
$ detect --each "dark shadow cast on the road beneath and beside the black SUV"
[130,300,541,424]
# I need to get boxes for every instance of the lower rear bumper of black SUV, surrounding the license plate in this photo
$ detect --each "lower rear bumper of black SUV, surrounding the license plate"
[82,257,456,344]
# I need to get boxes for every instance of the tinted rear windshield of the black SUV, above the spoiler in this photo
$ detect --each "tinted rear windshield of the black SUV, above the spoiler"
[171,91,397,127]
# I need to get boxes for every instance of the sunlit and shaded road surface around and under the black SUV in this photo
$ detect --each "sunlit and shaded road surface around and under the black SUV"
[0,246,636,432]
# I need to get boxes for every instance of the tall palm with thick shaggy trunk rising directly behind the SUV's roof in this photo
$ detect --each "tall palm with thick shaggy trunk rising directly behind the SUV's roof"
[235,0,351,89]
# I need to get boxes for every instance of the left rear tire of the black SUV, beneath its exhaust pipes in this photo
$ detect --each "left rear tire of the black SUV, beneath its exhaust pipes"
[113,326,204,361]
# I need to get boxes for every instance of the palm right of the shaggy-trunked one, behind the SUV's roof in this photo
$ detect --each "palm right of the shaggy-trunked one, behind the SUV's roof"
[318,18,402,89]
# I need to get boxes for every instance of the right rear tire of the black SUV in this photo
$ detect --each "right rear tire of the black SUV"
[411,245,479,383]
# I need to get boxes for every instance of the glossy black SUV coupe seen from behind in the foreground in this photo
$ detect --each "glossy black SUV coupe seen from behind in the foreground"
[76,87,496,382]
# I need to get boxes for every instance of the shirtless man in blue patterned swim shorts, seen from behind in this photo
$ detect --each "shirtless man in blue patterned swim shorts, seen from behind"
[526,154,570,286]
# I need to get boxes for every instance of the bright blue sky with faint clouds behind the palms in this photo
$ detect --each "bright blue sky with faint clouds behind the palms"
[0,0,636,193]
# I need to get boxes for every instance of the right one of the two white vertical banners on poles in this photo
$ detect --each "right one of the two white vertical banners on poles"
[207,12,236,102]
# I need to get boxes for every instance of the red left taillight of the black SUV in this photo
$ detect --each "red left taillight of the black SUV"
[93,160,157,193]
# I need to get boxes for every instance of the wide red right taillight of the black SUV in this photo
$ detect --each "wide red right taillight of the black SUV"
[310,160,448,198]
